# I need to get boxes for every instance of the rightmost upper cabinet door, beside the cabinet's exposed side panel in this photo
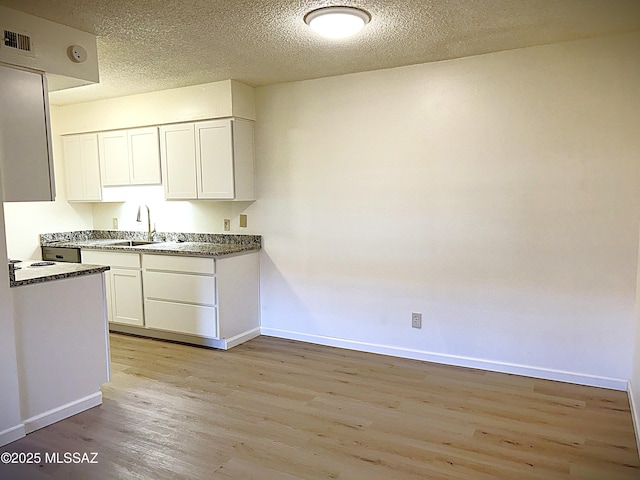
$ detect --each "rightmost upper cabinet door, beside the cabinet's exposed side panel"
[196,119,235,200]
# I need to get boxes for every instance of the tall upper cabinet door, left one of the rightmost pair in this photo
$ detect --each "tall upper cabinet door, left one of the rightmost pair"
[160,123,198,200]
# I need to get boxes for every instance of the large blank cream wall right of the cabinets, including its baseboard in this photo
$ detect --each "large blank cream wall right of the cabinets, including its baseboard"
[248,33,640,388]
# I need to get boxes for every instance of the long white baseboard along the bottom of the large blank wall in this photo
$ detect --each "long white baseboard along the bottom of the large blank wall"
[261,327,627,391]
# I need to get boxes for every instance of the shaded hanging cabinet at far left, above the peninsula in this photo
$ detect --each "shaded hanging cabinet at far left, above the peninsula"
[0,66,55,202]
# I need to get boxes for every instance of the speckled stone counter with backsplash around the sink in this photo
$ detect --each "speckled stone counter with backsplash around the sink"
[40,230,262,257]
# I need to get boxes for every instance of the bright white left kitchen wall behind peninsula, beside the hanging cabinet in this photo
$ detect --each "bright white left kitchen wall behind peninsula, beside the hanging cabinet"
[4,106,93,260]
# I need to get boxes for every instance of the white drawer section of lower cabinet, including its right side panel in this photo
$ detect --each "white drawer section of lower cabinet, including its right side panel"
[142,252,260,348]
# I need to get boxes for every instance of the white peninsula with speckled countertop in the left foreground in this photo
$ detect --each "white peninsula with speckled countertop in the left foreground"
[9,260,109,433]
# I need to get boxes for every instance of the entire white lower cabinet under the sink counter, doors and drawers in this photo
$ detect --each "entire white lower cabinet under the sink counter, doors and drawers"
[82,250,260,349]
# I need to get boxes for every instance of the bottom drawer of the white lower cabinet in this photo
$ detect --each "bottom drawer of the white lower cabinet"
[144,300,219,338]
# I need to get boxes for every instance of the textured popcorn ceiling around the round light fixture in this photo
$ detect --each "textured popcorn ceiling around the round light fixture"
[0,0,640,104]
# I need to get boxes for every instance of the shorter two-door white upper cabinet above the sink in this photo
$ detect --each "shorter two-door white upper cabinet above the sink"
[98,127,161,187]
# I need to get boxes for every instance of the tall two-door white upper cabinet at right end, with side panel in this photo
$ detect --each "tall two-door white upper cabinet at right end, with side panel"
[160,118,255,200]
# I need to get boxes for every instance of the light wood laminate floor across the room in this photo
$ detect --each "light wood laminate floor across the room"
[0,334,640,480]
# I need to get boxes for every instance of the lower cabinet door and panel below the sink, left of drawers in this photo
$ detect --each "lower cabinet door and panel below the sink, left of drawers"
[81,250,144,326]
